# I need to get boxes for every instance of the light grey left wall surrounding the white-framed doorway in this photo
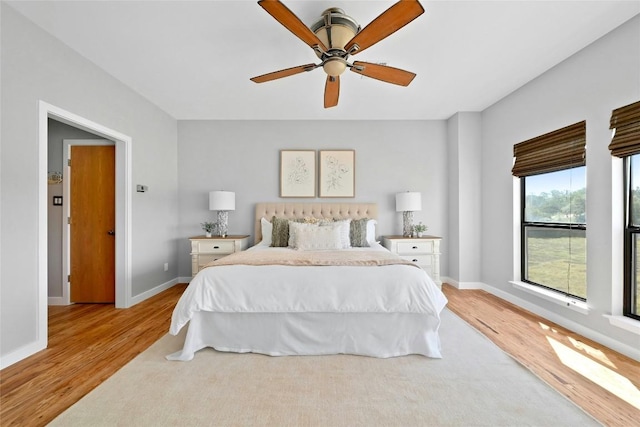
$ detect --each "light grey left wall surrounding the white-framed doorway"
[0,2,178,364]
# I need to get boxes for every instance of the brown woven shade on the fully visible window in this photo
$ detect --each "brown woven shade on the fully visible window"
[511,120,587,177]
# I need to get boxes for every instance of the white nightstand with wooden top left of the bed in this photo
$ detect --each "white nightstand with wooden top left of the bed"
[189,236,249,276]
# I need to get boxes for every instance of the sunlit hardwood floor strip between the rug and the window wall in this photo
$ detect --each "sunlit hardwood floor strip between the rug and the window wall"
[442,284,640,427]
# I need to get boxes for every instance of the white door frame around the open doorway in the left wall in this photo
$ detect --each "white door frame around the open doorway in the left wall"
[38,100,132,324]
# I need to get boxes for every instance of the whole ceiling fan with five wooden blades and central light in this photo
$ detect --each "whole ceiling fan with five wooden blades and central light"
[251,0,424,108]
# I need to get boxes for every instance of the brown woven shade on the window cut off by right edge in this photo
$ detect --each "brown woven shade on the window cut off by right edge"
[609,101,640,157]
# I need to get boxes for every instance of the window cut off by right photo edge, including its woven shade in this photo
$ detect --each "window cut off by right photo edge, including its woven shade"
[609,101,640,320]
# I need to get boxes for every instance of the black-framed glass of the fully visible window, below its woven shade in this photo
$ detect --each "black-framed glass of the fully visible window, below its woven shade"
[521,166,587,300]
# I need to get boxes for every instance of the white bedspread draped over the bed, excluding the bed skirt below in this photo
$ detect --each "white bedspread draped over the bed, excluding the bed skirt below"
[170,245,447,360]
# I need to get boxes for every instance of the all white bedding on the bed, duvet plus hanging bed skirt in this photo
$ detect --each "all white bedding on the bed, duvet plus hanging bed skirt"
[168,244,447,360]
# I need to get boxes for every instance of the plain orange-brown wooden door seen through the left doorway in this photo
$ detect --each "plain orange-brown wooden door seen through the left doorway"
[69,145,116,303]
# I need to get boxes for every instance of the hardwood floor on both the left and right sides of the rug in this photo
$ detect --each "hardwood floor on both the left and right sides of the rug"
[0,284,640,427]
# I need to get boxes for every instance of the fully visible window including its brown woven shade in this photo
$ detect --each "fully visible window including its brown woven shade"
[512,121,587,300]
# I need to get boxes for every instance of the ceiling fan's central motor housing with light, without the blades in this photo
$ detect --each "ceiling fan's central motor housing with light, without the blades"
[311,7,360,76]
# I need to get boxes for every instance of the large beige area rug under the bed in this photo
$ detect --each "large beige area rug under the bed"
[51,309,600,427]
